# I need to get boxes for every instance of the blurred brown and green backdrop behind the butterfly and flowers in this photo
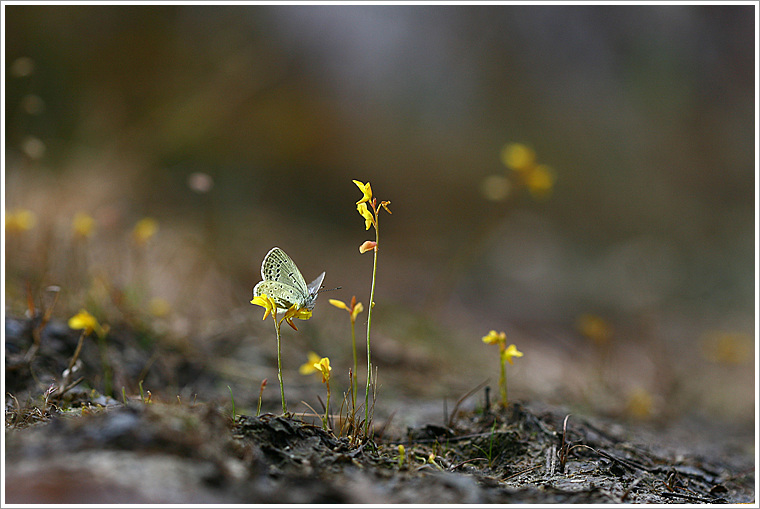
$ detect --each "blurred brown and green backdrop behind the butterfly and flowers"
[4,5,757,428]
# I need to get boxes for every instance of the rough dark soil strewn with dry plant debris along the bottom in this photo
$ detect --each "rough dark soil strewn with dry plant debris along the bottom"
[6,396,754,504]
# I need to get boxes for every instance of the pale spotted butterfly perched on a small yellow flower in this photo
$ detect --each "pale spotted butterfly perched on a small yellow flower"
[253,247,325,311]
